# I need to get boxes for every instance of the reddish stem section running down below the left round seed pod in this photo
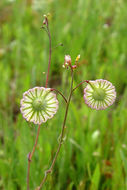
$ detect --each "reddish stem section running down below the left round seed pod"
[27,125,41,190]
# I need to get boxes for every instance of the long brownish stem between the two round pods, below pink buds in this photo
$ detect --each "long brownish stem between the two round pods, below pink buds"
[37,69,73,190]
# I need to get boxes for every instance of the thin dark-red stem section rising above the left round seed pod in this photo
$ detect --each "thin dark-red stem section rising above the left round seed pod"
[45,20,52,88]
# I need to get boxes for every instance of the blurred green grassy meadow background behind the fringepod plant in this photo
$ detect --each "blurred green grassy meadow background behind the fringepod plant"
[0,0,127,190]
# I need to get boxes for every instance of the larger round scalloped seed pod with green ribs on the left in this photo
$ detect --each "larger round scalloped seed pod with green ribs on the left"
[20,87,58,124]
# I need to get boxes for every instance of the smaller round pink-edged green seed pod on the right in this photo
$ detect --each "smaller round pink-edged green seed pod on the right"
[84,79,116,110]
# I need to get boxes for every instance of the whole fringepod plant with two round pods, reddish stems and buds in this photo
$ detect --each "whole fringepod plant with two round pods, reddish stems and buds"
[20,15,116,190]
